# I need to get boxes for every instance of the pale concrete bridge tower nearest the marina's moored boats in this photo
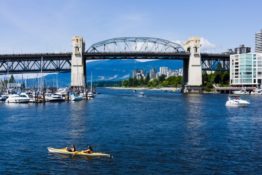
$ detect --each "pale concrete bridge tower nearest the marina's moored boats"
[71,36,86,89]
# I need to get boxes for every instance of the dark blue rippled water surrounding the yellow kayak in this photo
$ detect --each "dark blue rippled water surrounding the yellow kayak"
[0,89,262,174]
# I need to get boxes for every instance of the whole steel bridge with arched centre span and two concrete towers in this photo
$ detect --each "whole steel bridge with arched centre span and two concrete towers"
[0,36,229,92]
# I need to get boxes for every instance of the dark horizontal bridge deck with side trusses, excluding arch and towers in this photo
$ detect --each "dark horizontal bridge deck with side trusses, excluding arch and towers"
[0,51,229,74]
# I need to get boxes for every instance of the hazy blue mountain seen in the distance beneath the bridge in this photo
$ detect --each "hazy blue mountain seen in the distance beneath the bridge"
[26,60,183,87]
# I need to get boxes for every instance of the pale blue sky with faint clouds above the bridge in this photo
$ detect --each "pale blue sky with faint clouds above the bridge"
[0,0,262,53]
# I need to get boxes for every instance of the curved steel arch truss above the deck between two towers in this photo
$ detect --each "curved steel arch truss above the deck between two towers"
[87,37,185,53]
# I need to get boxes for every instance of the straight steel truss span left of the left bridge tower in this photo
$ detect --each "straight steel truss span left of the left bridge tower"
[0,54,71,74]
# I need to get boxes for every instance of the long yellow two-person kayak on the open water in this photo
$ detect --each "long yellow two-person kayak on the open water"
[47,147,112,158]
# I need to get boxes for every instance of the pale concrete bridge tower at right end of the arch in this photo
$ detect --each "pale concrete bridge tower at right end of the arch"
[184,37,202,93]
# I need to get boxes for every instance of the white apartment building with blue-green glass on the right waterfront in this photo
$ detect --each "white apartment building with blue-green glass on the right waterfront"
[230,53,262,87]
